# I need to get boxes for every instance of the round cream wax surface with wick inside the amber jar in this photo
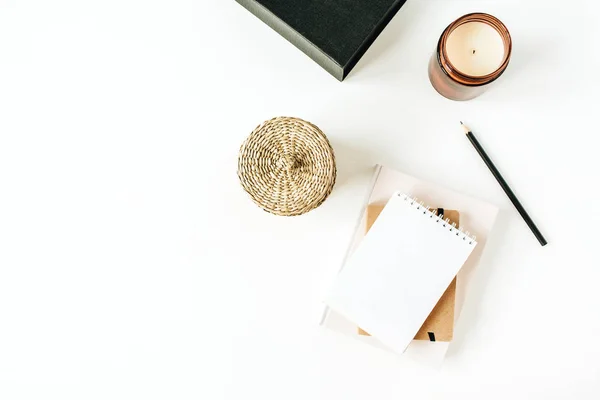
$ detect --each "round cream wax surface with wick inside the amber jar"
[446,22,504,76]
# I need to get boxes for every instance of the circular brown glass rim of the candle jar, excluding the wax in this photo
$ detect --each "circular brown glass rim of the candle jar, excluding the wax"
[437,12,512,86]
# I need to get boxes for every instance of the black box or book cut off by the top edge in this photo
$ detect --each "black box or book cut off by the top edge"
[236,0,406,81]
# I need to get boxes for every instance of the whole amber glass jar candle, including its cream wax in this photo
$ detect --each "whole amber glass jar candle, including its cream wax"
[429,13,512,100]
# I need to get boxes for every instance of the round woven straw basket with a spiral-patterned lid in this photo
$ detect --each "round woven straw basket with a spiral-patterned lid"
[238,117,336,216]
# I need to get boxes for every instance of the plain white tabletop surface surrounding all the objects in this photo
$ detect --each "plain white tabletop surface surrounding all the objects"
[0,0,600,400]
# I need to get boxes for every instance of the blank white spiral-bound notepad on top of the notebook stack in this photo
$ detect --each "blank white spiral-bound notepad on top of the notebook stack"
[325,193,477,353]
